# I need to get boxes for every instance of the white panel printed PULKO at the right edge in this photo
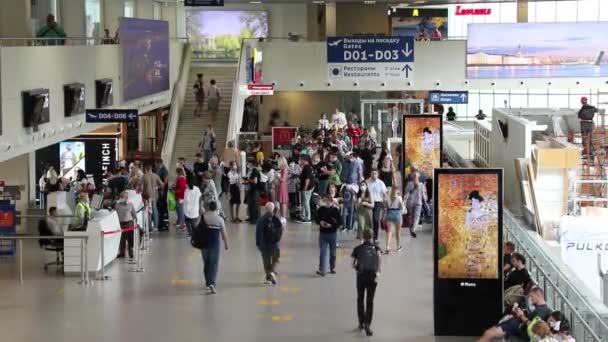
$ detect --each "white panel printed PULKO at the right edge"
[559,216,608,300]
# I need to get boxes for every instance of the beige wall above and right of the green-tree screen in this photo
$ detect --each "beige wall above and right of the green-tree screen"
[188,3,308,37]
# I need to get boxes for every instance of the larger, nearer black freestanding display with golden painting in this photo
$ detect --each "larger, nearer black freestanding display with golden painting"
[433,169,503,336]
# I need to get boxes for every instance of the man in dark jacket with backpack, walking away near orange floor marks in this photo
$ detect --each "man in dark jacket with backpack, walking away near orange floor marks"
[255,202,283,285]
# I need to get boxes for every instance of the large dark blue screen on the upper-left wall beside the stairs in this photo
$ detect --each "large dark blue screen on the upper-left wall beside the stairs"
[119,18,169,101]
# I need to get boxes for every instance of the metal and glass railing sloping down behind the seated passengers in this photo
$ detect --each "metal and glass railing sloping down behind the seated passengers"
[504,210,608,342]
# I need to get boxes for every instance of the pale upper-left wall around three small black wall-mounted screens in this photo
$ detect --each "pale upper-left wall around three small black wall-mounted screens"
[0,42,183,161]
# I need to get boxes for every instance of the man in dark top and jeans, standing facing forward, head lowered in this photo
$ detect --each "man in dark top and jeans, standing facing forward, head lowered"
[317,194,341,277]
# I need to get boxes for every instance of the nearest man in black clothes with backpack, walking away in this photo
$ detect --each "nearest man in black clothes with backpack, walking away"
[351,229,381,336]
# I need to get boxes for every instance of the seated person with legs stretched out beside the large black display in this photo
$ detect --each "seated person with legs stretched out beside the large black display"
[479,287,552,342]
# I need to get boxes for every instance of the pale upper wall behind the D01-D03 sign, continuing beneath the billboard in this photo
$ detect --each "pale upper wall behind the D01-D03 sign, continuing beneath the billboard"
[260,40,608,91]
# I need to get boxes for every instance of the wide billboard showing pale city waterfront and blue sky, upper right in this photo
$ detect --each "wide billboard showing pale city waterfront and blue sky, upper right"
[467,22,608,78]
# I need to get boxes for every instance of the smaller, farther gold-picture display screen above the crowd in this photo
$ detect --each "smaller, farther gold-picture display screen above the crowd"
[402,114,443,181]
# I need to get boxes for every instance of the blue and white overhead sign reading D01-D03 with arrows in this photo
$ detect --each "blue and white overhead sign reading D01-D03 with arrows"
[327,37,414,79]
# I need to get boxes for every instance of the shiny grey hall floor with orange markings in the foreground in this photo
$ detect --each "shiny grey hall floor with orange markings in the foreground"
[0,219,474,342]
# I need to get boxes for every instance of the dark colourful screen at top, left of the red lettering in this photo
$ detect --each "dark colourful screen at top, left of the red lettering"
[389,7,448,40]
